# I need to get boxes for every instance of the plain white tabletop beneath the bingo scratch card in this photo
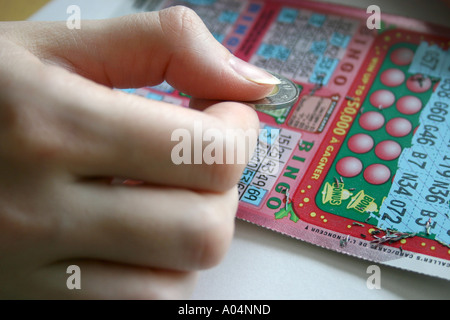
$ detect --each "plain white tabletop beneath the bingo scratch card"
[31,0,450,300]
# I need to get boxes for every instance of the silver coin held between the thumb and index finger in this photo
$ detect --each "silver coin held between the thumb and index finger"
[245,71,300,110]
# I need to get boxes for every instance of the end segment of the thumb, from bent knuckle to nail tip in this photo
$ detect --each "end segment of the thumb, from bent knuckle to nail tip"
[156,7,280,101]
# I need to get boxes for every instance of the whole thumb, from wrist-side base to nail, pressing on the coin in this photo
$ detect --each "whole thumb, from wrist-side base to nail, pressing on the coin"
[18,6,279,101]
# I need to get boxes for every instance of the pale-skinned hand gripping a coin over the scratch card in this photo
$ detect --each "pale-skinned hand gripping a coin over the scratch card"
[0,7,282,299]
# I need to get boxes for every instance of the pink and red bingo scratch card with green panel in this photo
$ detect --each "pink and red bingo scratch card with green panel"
[121,0,450,279]
